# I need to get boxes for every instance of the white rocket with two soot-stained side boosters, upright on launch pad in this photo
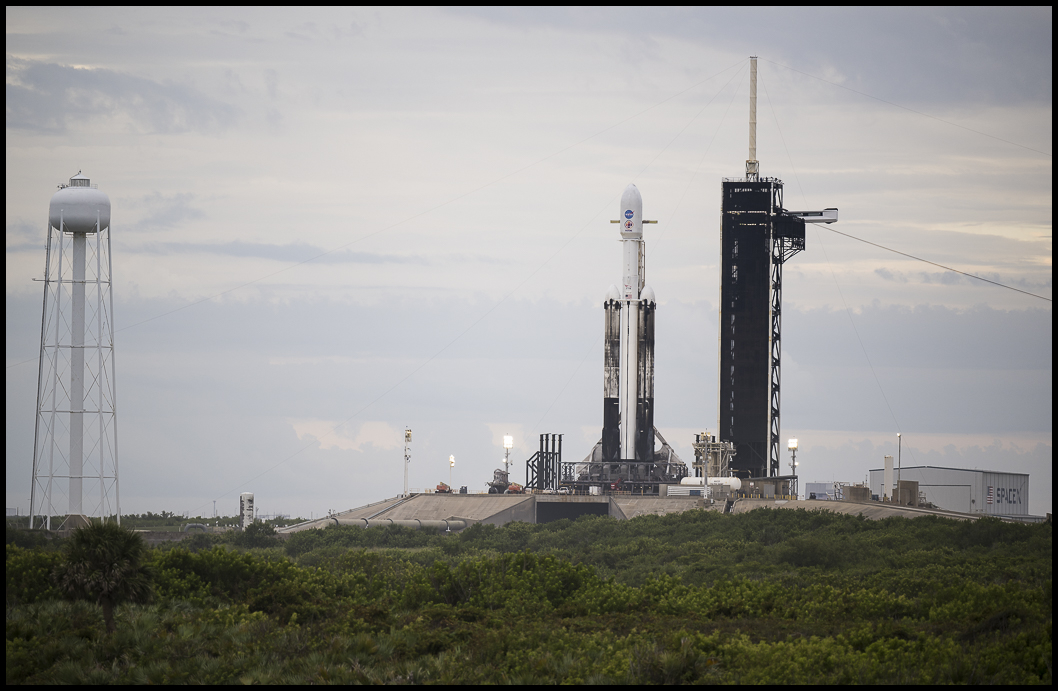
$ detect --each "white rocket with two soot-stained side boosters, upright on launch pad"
[602,184,656,463]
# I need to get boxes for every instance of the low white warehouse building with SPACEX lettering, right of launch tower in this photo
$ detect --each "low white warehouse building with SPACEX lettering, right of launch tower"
[870,466,1028,516]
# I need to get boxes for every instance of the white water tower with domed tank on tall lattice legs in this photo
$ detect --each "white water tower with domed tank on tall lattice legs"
[30,171,121,529]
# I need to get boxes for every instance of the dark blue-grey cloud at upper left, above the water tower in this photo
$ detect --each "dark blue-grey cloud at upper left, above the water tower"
[6,58,238,133]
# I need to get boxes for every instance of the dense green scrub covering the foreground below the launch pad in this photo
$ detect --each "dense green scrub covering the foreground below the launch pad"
[6,510,1052,685]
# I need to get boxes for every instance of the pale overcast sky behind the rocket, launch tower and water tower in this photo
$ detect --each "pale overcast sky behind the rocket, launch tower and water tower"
[5,7,1053,516]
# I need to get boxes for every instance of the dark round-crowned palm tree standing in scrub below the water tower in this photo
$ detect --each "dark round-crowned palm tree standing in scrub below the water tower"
[55,522,153,633]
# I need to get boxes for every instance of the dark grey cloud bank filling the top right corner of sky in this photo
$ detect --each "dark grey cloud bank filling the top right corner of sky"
[445,7,1053,106]
